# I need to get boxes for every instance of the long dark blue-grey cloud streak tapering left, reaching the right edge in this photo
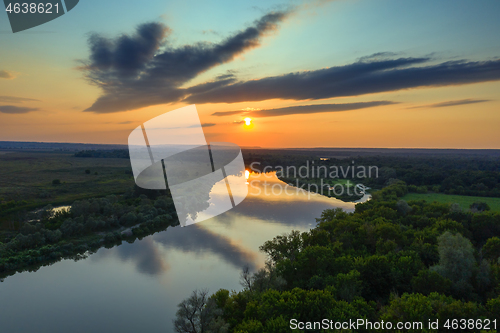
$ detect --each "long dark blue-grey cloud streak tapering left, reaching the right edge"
[185,58,500,103]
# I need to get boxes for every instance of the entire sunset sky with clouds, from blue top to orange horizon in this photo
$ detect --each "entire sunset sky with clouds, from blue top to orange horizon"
[0,0,500,149]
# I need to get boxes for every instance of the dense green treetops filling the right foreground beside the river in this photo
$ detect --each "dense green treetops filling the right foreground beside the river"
[178,181,500,333]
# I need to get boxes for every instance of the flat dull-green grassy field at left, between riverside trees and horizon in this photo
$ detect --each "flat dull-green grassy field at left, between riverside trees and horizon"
[0,151,134,225]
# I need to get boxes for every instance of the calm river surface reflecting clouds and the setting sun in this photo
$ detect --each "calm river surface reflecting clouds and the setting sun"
[0,175,368,333]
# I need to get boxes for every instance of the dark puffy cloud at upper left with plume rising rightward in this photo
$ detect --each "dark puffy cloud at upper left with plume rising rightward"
[81,11,290,113]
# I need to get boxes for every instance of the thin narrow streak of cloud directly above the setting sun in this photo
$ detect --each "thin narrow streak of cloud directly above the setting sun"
[212,101,397,117]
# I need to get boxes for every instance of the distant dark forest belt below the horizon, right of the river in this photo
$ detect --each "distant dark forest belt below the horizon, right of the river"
[245,152,500,197]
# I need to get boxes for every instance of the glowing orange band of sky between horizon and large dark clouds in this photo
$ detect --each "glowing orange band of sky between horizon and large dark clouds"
[0,80,500,148]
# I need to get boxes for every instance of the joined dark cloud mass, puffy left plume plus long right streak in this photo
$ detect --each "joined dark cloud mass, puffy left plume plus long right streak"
[81,10,500,116]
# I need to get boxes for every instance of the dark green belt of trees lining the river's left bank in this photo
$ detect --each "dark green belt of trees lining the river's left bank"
[0,189,178,275]
